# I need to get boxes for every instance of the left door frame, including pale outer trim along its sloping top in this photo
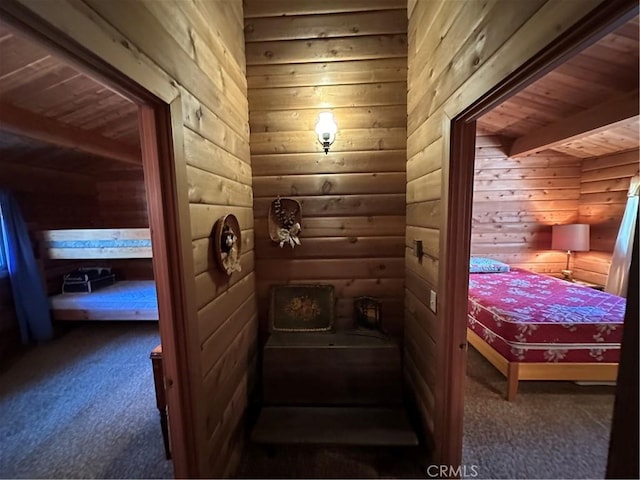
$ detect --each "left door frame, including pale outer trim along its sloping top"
[0,0,199,478]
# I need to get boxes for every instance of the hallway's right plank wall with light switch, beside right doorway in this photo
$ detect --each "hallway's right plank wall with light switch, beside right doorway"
[405,0,599,462]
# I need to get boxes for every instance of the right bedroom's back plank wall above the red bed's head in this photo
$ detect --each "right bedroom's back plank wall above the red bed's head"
[471,135,582,274]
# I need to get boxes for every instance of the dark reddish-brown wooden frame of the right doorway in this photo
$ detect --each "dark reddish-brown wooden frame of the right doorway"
[441,0,637,472]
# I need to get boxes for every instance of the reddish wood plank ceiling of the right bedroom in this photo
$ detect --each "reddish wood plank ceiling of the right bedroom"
[478,17,639,158]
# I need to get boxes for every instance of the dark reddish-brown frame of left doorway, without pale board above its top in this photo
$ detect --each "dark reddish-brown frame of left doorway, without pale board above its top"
[0,2,197,477]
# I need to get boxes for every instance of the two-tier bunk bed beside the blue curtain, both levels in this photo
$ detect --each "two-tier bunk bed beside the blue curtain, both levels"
[39,228,158,320]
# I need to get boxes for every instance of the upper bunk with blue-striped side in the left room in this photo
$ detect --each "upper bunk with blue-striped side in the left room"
[39,228,152,260]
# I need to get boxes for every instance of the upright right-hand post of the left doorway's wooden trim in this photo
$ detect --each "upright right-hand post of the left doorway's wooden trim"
[139,98,201,478]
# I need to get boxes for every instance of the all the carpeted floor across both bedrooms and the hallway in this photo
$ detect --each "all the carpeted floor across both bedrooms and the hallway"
[0,323,614,478]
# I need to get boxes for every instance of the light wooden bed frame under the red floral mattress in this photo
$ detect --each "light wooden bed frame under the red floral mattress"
[467,328,618,401]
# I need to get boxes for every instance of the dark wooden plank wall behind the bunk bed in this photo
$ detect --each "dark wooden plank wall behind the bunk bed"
[0,162,153,295]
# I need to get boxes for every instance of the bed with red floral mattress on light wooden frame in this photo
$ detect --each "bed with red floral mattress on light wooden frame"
[467,260,626,400]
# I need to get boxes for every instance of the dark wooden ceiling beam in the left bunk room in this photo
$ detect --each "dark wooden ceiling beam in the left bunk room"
[0,103,142,165]
